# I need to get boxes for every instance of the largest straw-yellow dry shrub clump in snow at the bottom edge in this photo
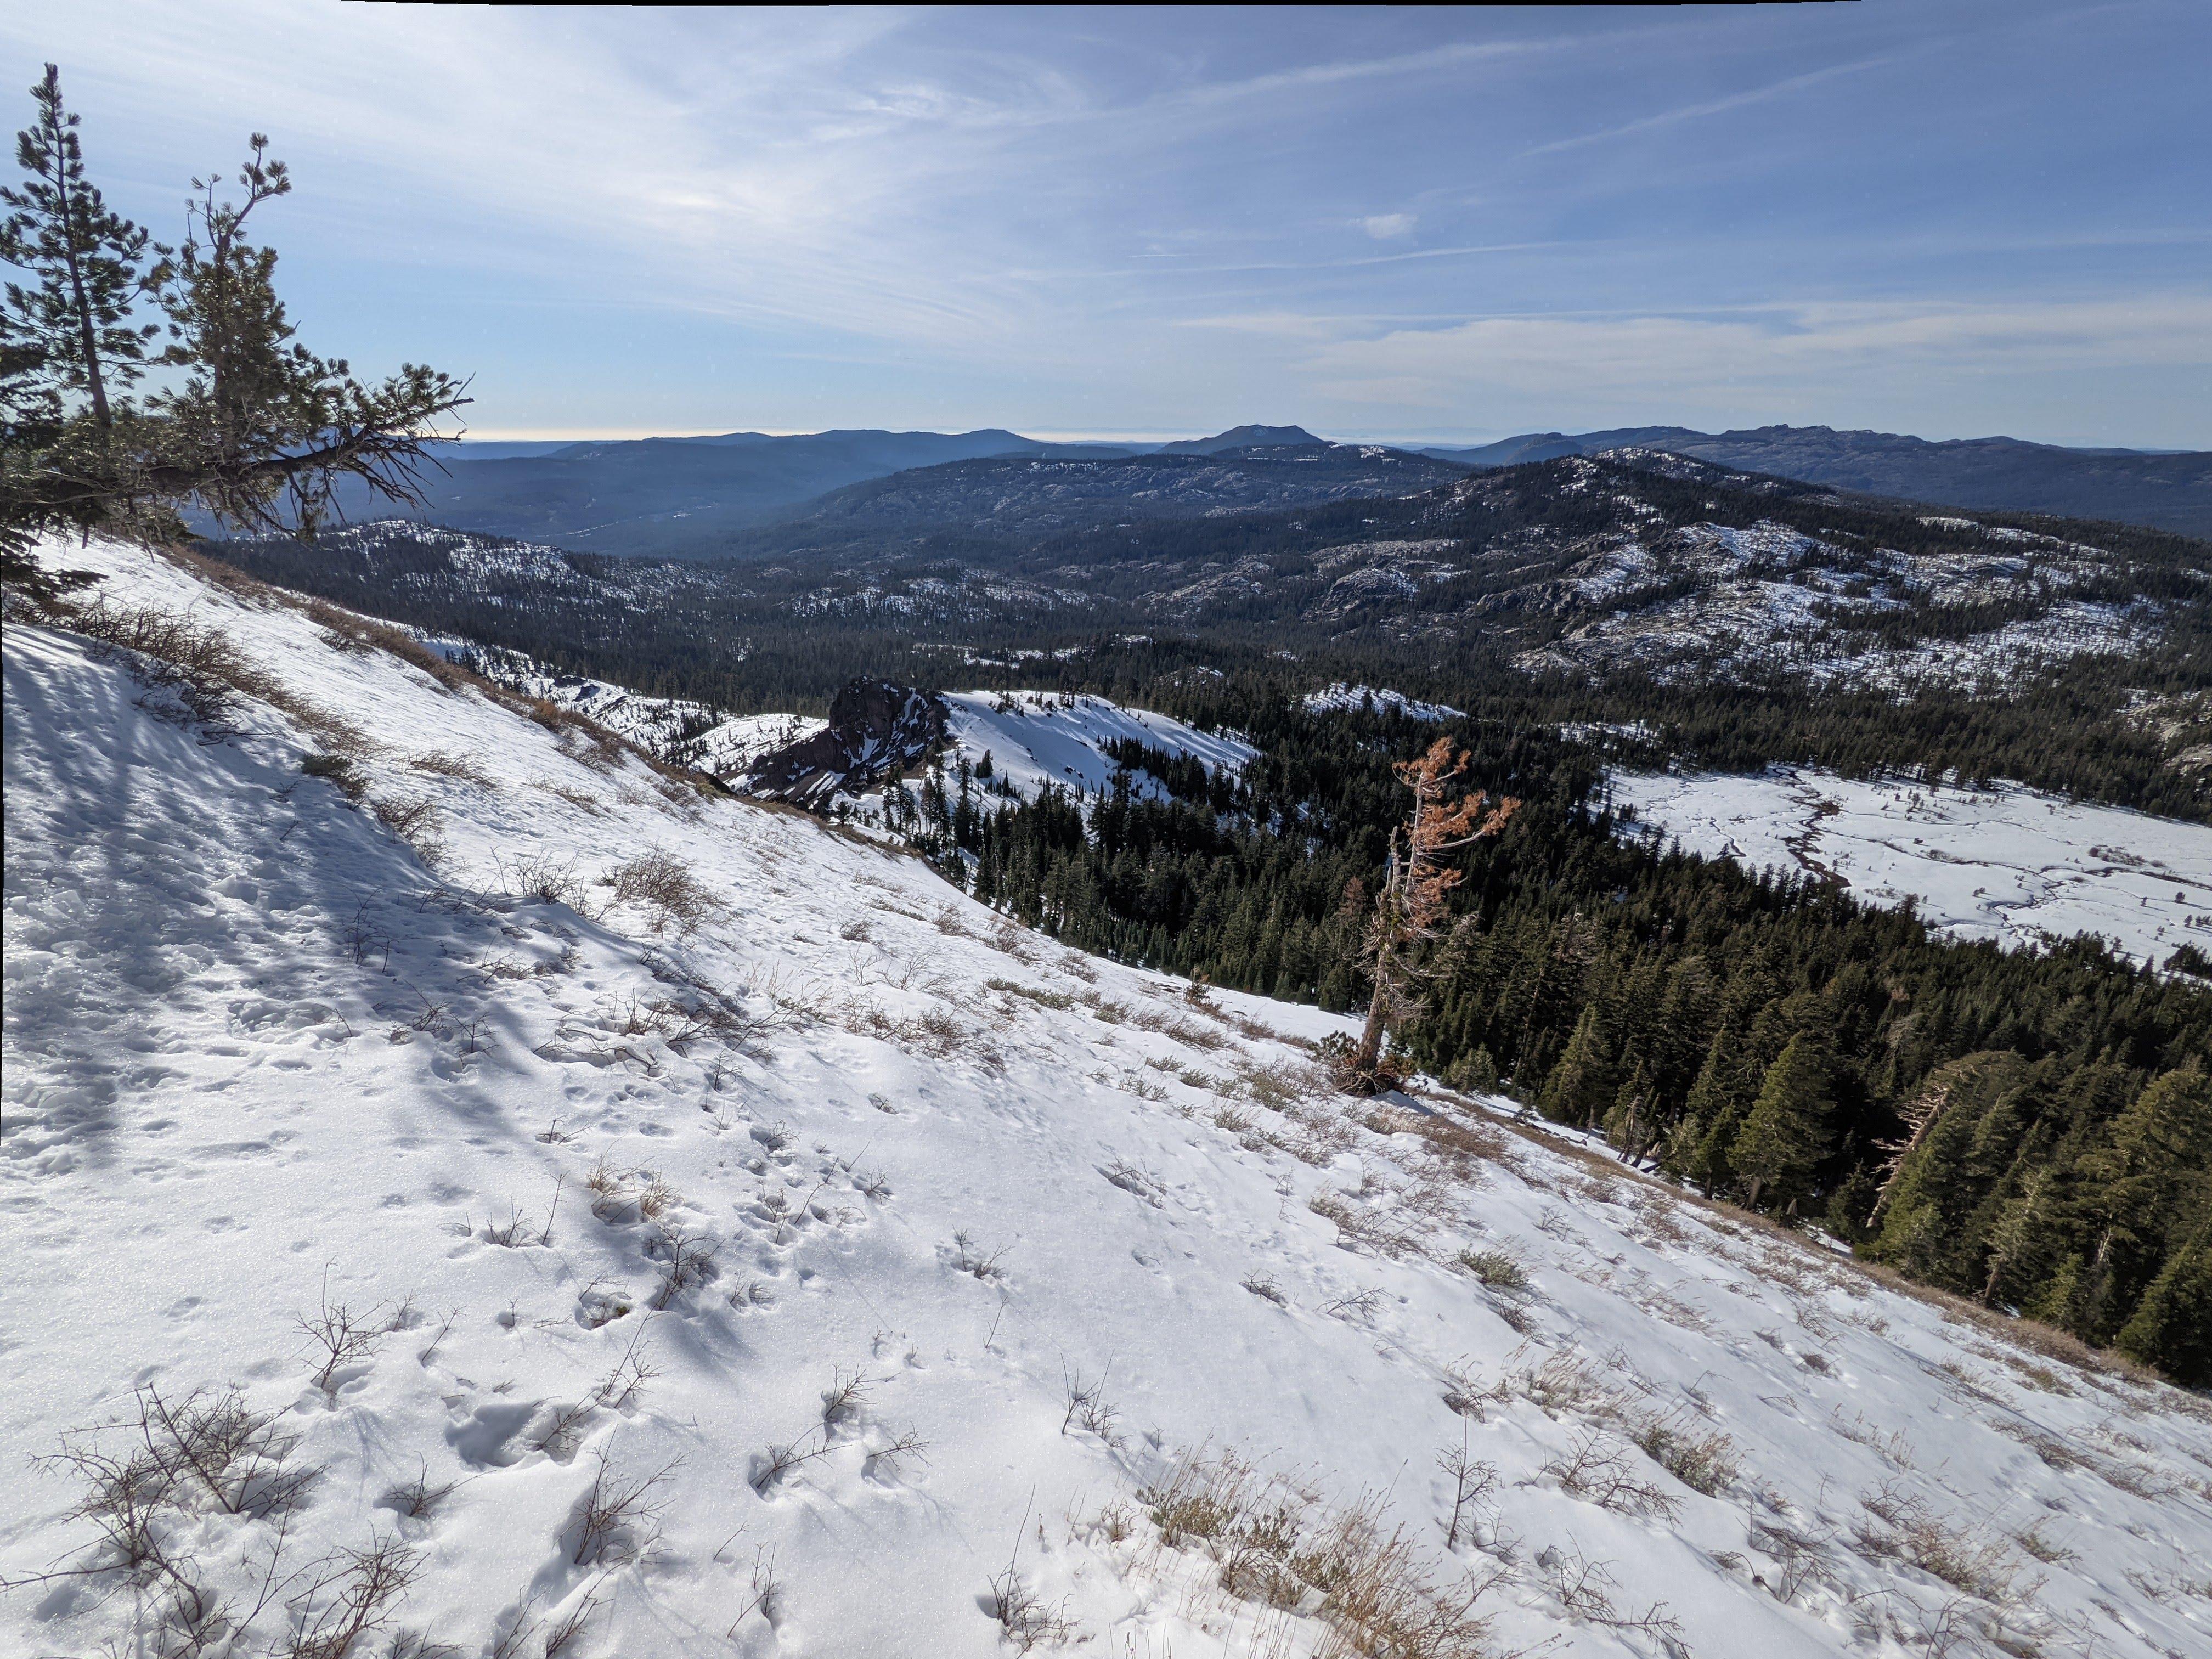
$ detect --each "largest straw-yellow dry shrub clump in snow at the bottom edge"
[1139,1453,1489,1659]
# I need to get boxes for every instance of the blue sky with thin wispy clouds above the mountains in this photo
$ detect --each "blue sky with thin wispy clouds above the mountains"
[17,0,2212,449]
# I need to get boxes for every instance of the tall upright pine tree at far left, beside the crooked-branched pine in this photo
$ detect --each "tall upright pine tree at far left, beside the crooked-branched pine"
[0,64,161,431]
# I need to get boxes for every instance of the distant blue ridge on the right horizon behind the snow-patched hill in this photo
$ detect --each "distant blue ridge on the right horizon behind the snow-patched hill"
[1420,427,2212,535]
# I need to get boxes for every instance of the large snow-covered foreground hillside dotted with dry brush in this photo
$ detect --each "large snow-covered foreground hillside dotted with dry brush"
[0,546,2212,1659]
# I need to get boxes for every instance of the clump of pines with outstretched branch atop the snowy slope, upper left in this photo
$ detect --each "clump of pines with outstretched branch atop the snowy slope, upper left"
[0,80,469,566]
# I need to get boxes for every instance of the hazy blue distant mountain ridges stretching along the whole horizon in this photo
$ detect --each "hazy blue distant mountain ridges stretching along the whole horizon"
[371,422,2212,557]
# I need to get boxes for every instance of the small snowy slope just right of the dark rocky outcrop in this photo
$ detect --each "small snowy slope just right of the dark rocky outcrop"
[945,690,1259,801]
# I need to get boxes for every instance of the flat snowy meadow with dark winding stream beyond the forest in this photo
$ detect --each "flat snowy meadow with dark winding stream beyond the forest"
[1608,768,2212,962]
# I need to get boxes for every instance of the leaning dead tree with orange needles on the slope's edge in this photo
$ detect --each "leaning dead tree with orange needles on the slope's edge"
[1352,737,1520,1088]
